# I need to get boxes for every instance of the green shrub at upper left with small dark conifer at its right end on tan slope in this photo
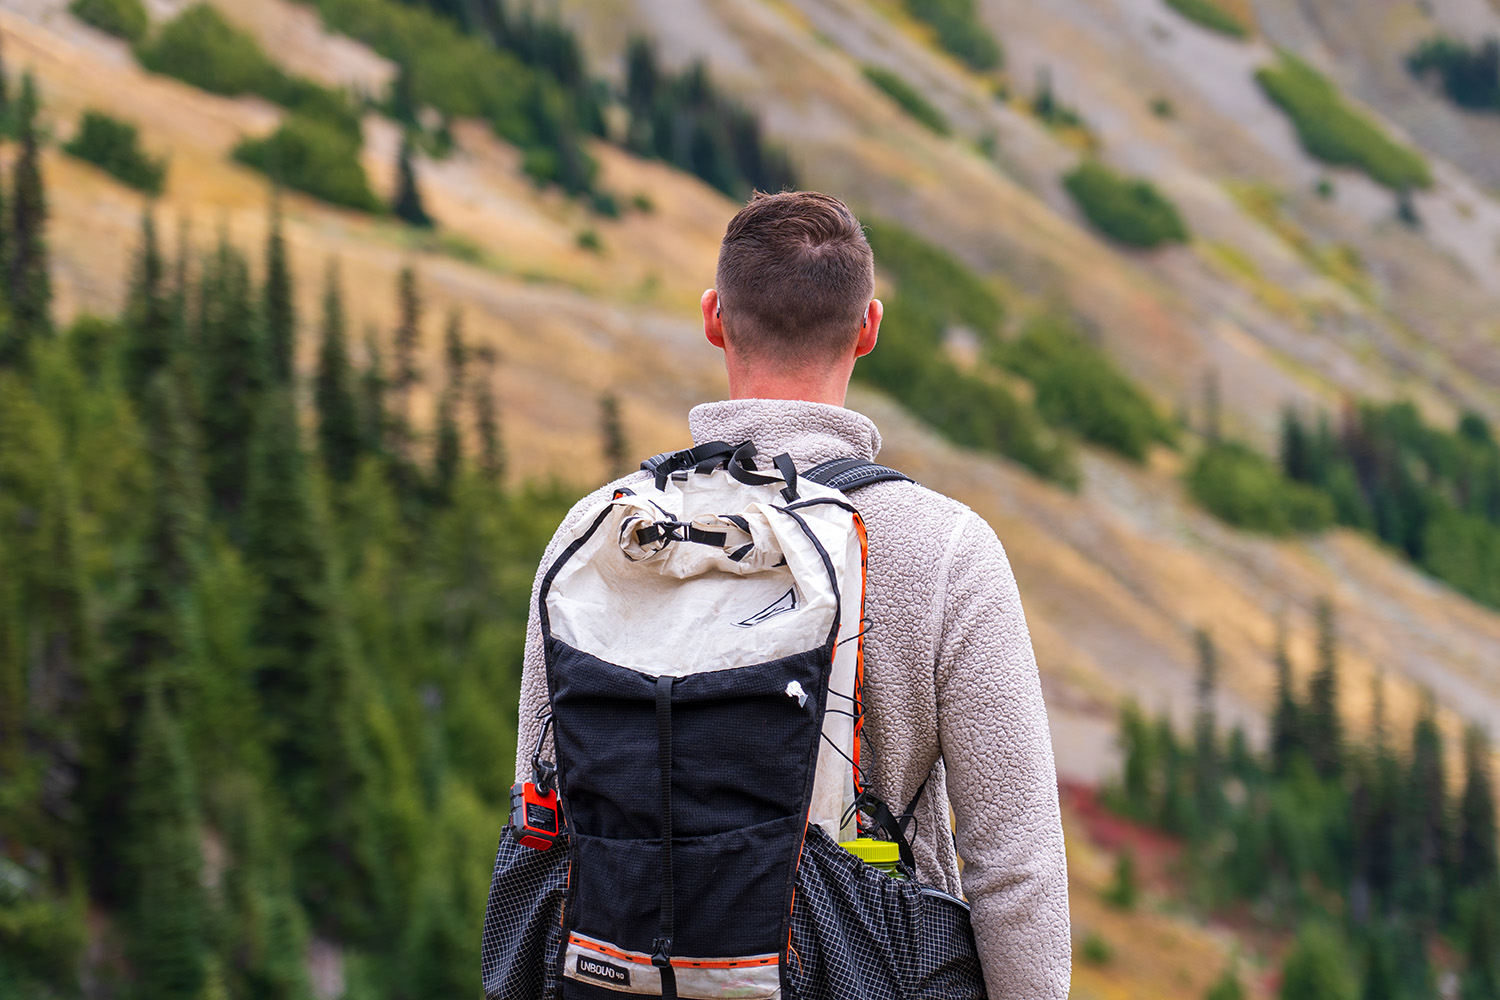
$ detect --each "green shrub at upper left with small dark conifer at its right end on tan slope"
[234,114,381,211]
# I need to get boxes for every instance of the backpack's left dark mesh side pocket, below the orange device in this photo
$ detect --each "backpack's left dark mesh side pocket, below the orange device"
[480,826,569,1000]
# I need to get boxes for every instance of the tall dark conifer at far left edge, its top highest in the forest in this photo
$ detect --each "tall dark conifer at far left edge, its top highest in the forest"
[6,73,53,342]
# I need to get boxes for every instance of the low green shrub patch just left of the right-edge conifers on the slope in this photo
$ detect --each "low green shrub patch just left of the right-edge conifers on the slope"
[1188,442,1334,535]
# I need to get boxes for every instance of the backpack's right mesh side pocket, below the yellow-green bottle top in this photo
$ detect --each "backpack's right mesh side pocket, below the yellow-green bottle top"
[785,826,986,1000]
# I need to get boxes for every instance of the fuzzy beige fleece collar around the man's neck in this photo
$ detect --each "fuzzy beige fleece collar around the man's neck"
[687,399,881,468]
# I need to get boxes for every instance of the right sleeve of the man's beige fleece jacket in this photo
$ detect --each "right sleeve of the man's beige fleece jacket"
[936,513,1073,1000]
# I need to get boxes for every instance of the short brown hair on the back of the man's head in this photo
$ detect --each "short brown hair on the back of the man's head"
[716,190,875,361]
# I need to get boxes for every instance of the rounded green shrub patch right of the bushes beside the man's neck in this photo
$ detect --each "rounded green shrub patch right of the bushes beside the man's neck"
[999,316,1173,462]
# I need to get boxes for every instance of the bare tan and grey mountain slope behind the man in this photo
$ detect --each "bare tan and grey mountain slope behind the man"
[0,0,1500,778]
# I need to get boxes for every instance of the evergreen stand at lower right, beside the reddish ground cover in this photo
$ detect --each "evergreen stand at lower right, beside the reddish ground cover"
[1104,601,1500,1000]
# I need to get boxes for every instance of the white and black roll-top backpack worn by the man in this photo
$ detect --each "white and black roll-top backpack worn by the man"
[483,442,986,1000]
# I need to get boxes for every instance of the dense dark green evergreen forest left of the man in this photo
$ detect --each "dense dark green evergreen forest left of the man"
[0,64,567,1000]
